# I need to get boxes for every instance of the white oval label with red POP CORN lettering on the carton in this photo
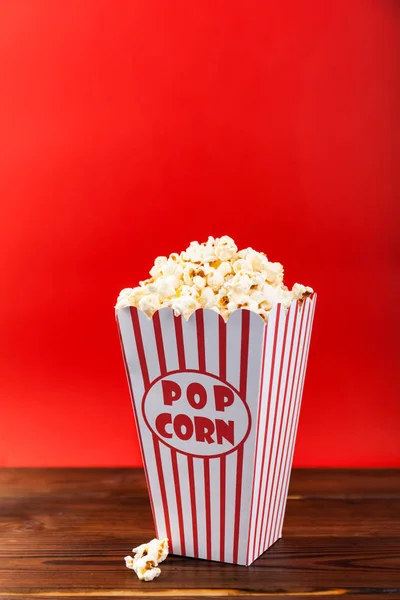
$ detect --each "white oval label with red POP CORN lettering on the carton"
[142,371,250,457]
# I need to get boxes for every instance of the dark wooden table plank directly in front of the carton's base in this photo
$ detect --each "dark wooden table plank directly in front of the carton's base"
[0,537,400,597]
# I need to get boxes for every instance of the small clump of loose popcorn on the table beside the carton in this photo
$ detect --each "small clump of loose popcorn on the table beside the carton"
[124,538,168,581]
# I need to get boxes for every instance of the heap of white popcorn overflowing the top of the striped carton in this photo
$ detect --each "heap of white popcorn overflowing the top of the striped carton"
[115,235,313,321]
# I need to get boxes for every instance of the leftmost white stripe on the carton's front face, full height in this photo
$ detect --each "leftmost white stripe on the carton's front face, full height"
[117,308,167,537]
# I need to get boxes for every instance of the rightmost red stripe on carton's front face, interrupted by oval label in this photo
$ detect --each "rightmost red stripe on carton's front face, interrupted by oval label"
[233,310,250,563]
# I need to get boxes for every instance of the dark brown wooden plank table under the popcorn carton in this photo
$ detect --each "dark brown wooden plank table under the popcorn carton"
[0,469,400,600]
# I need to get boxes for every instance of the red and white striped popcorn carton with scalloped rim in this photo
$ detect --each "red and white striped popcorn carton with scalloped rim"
[117,294,316,565]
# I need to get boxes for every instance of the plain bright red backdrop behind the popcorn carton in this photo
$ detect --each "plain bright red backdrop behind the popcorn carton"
[0,0,400,466]
